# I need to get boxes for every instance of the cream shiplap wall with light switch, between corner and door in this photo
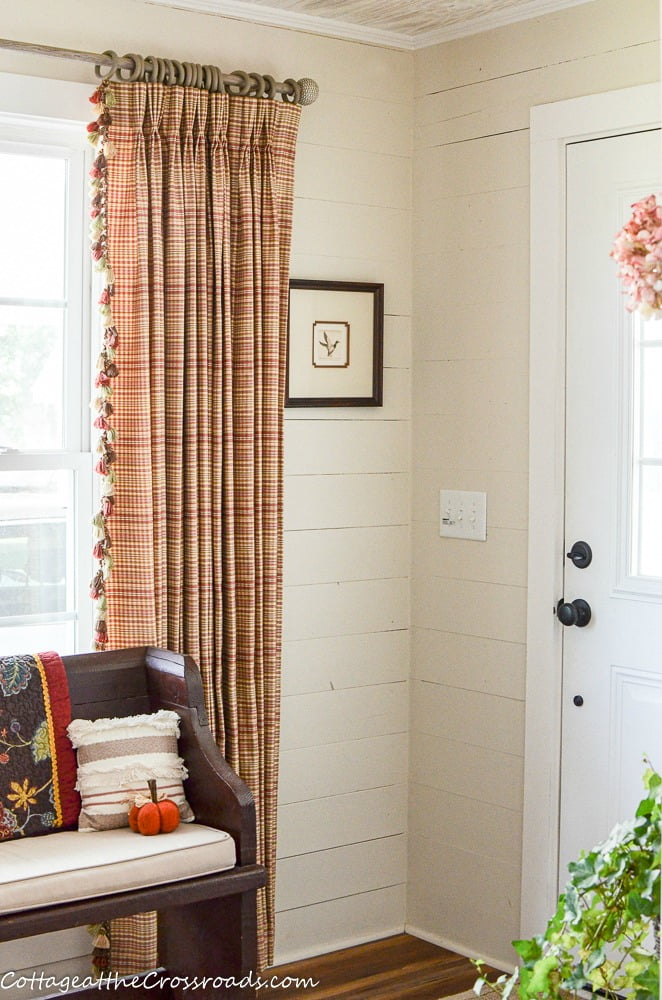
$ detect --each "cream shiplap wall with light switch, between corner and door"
[407,0,659,964]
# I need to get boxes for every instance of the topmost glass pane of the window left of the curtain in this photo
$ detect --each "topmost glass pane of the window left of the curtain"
[0,152,67,300]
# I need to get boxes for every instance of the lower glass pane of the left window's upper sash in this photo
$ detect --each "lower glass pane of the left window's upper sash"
[0,305,64,451]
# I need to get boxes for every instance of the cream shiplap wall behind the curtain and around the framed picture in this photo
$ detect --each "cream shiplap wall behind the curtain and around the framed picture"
[0,0,413,961]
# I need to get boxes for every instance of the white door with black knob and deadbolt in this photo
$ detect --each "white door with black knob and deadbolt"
[558,130,662,888]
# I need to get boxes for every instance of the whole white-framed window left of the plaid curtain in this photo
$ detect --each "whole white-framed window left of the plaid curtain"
[0,103,92,654]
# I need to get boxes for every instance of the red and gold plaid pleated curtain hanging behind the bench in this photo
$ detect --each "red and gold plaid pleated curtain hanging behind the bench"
[93,83,300,967]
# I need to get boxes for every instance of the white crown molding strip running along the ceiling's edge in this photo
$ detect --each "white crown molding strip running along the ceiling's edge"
[148,0,590,52]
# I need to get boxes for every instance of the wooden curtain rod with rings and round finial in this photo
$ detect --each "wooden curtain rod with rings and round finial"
[0,38,319,105]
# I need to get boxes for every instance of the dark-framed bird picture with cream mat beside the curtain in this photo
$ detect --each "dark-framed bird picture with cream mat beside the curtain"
[285,278,384,406]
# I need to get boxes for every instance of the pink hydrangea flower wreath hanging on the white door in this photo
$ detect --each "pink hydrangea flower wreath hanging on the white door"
[611,194,662,319]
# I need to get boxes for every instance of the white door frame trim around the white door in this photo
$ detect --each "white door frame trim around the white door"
[521,84,662,937]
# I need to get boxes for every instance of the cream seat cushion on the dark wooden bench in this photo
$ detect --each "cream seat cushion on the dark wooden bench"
[0,823,235,914]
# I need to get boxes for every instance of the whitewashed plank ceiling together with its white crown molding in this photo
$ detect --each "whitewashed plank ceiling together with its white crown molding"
[148,0,600,49]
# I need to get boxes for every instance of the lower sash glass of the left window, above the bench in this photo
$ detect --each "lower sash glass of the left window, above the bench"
[0,470,74,624]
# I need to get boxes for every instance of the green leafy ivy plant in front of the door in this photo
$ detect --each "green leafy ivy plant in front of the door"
[474,767,662,1000]
